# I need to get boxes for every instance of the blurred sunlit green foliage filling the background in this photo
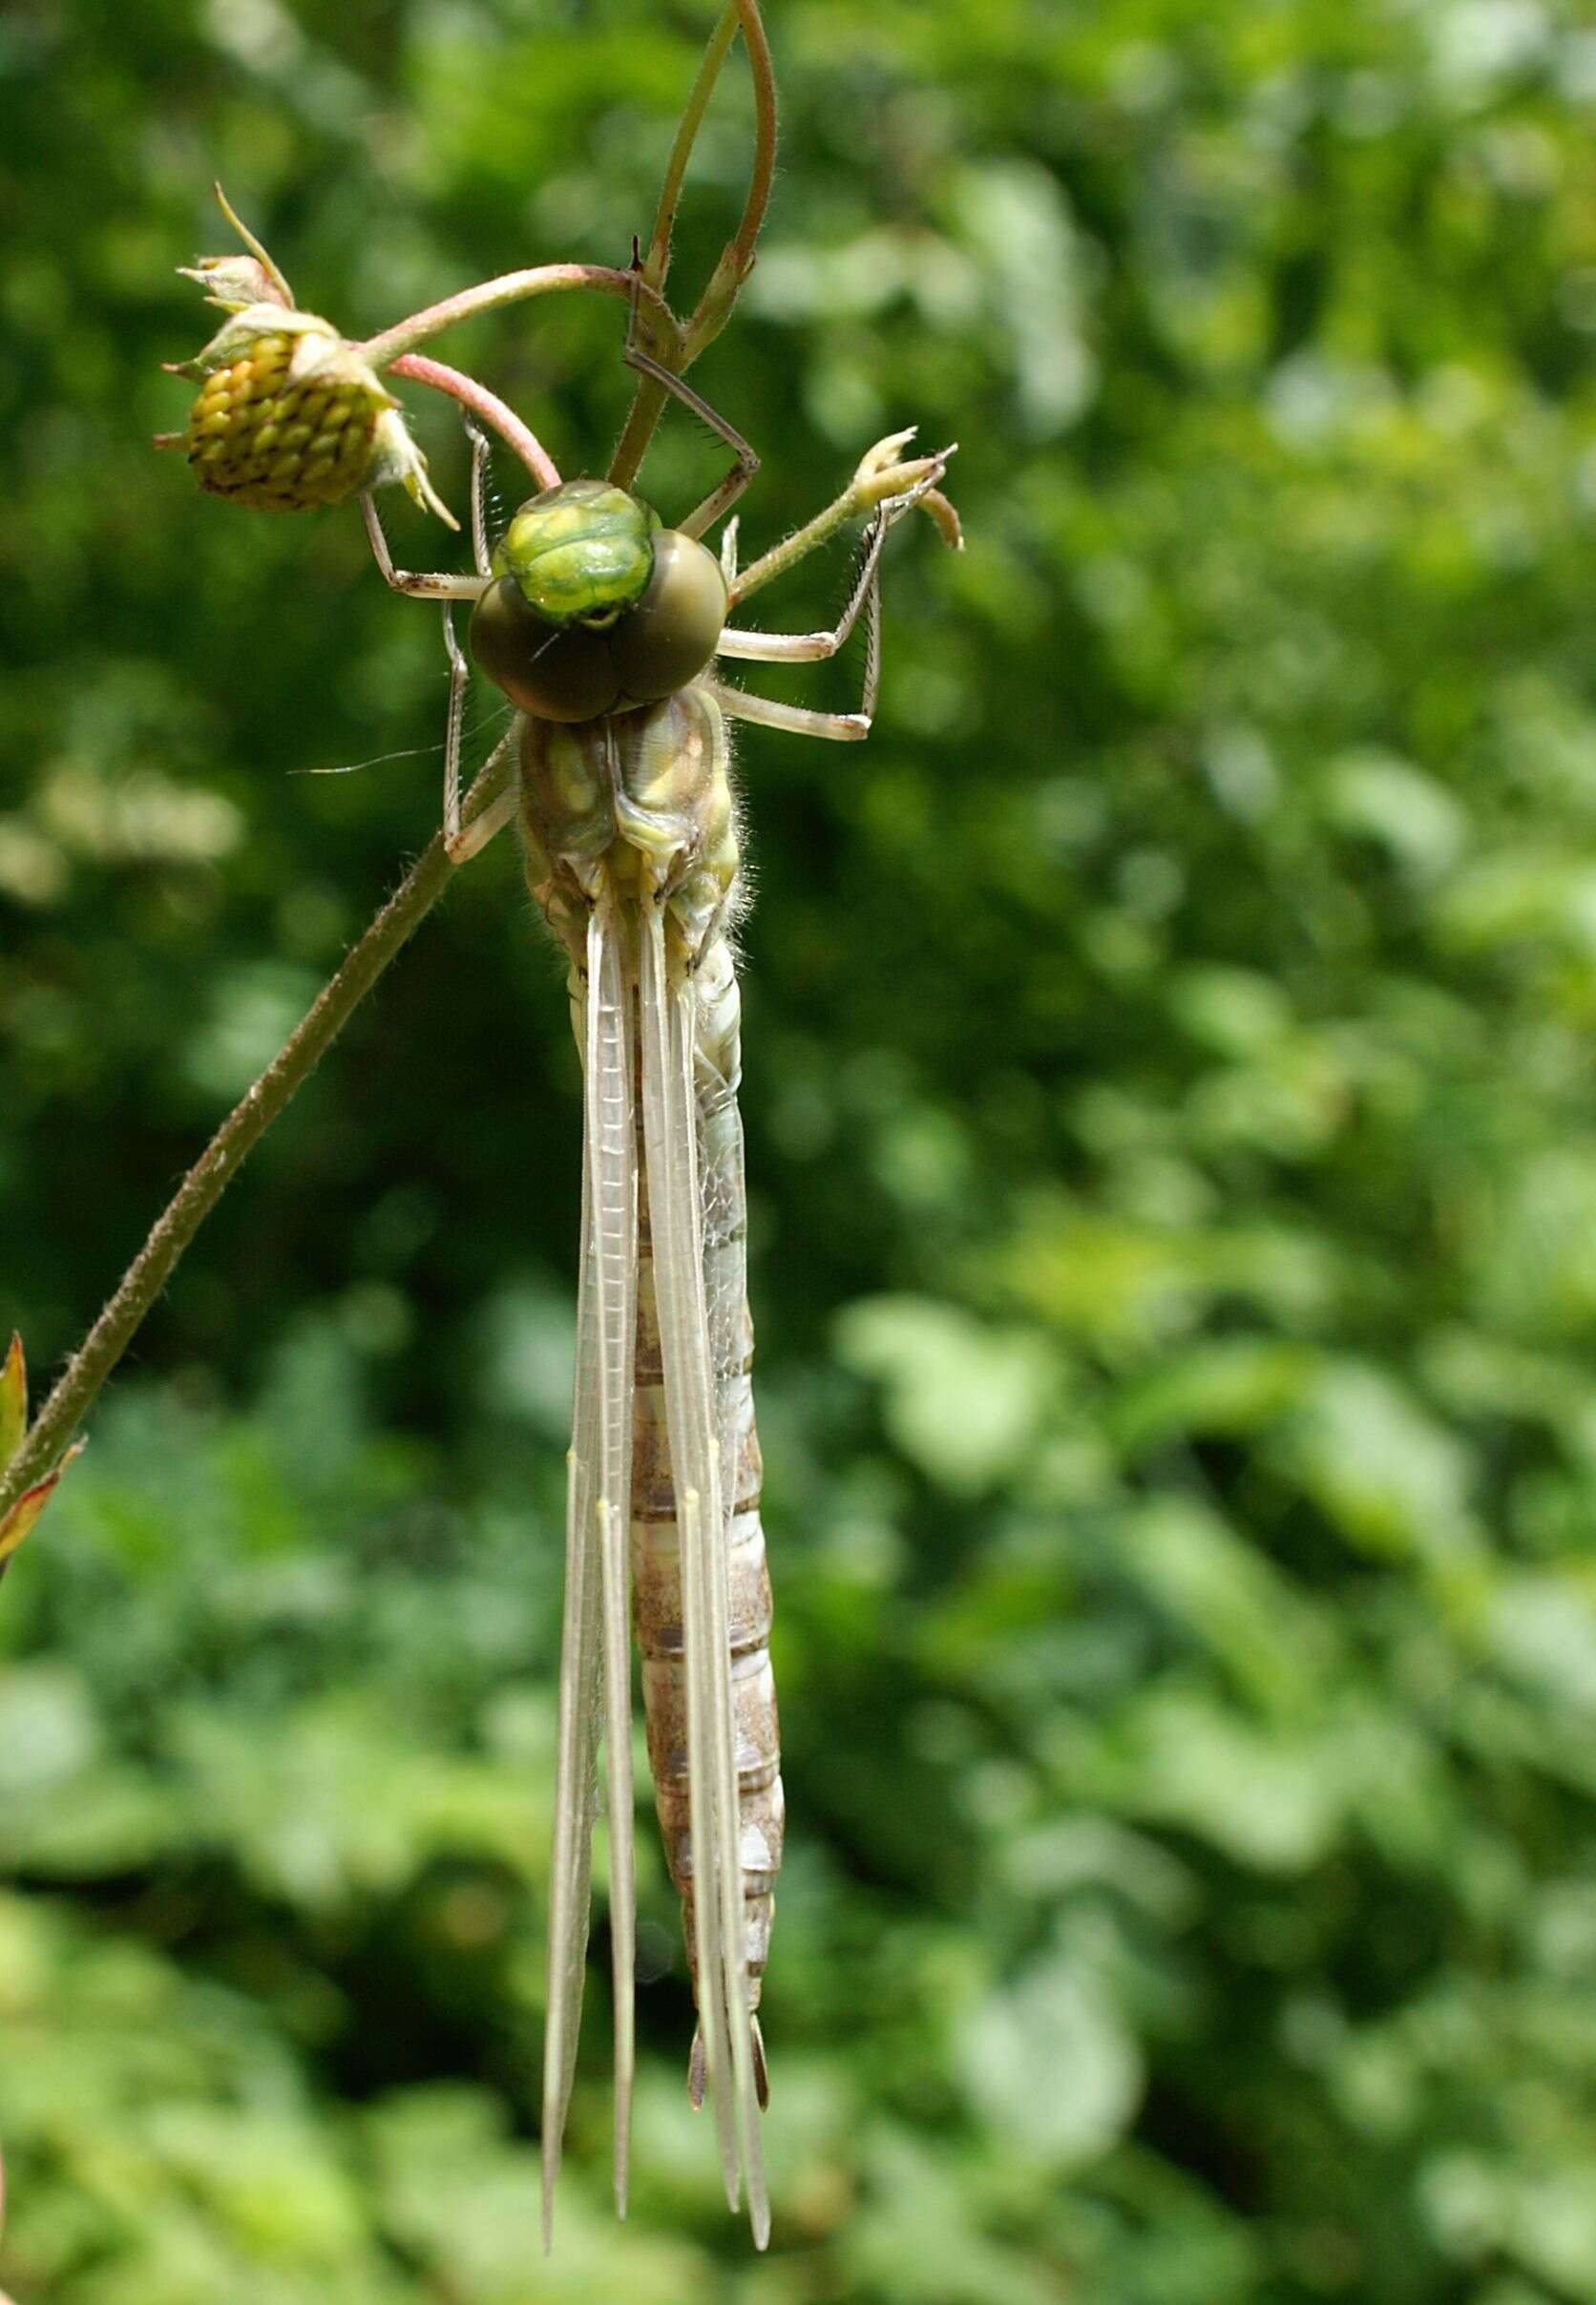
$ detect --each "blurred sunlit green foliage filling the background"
[0,0,1596,2305]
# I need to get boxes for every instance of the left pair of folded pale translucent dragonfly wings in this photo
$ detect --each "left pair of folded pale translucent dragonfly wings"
[542,890,637,2245]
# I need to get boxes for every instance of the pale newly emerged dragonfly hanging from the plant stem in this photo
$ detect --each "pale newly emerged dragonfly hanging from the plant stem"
[365,334,946,2248]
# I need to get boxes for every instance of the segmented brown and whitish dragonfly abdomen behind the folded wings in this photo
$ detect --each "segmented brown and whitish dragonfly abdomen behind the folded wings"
[632,932,785,2007]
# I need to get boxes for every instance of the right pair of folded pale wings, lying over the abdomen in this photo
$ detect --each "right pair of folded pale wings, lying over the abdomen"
[639,899,770,2248]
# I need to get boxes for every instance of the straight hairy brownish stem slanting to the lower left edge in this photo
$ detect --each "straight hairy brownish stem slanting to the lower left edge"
[0,761,510,1515]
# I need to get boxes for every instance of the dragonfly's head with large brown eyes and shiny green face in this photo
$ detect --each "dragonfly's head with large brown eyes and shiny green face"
[471,479,726,722]
